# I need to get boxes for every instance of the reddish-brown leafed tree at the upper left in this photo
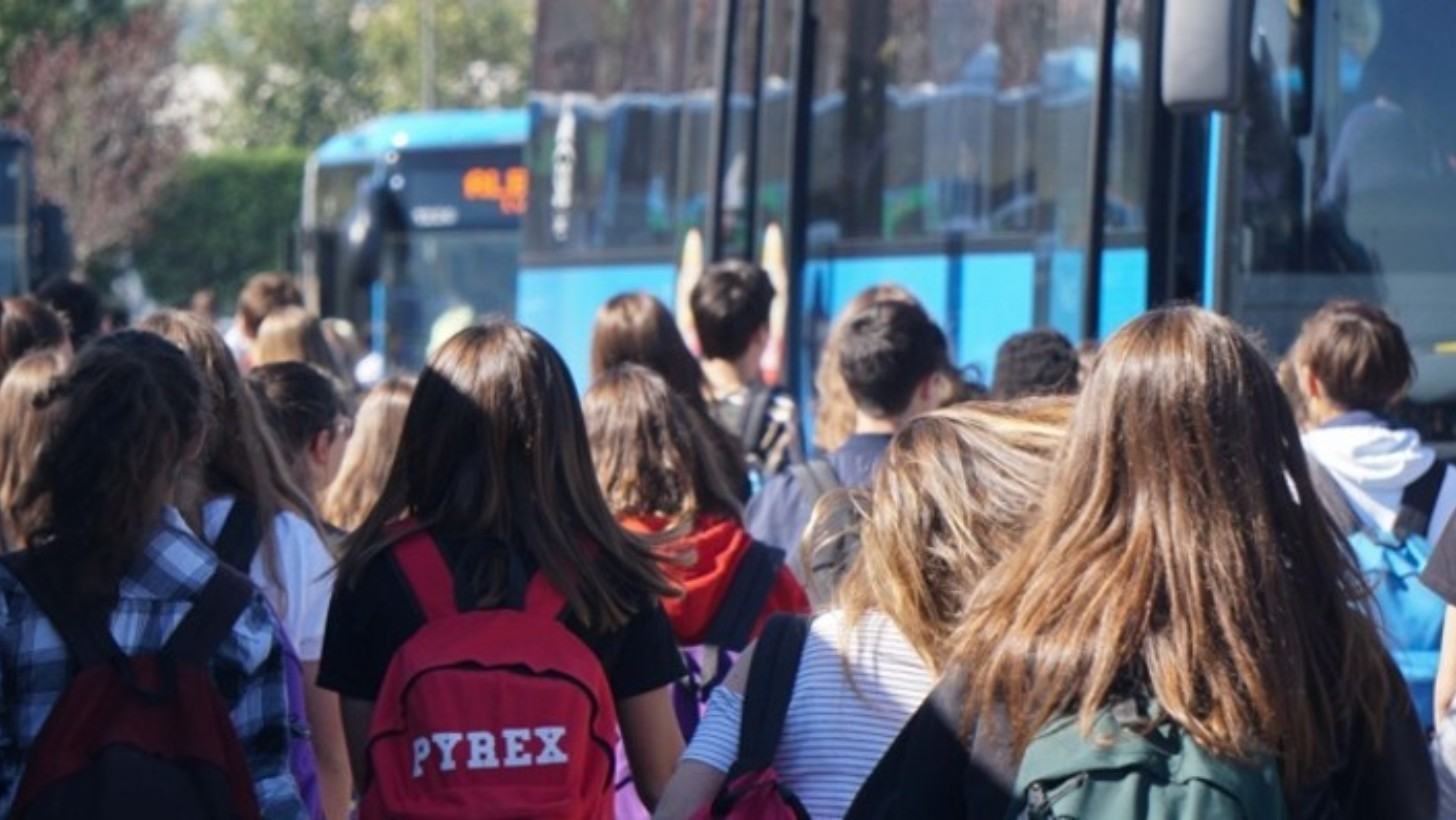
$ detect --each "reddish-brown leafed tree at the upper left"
[10,9,183,269]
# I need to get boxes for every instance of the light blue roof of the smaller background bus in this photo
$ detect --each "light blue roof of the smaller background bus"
[313,108,529,165]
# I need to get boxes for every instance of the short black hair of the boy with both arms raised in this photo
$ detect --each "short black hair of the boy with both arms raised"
[690,259,773,360]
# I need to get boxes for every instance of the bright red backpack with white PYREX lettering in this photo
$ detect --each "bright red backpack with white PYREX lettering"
[360,532,617,820]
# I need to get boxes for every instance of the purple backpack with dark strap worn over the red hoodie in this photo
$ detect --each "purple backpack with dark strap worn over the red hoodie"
[616,542,783,820]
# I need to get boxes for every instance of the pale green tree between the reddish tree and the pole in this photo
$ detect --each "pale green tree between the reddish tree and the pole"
[192,0,374,147]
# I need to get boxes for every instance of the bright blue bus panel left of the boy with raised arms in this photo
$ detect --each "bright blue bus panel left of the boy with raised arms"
[515,265,677,392]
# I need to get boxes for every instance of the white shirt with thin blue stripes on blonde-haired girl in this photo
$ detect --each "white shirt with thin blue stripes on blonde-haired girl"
[683,612,935,819]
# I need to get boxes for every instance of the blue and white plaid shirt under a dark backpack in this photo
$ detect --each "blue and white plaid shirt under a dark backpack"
[0,508,307,819]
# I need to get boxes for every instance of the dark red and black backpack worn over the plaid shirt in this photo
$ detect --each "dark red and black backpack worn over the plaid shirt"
[3,552,259,820]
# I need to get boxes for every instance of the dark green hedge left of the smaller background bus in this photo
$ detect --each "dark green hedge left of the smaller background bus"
[135,149,307,304]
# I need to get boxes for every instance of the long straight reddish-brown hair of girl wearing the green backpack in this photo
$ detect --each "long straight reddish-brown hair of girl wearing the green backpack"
[958,307,1395,788]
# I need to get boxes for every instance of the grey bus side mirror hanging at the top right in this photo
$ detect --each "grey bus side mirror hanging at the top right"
[1162,0,1254,112]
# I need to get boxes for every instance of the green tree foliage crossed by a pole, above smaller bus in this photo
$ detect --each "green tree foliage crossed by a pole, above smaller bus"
[361,0,534,111]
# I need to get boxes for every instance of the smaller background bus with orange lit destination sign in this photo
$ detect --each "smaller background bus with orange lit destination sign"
[300,109,530,370]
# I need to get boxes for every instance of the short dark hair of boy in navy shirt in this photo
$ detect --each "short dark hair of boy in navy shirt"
[839,301,949,418]
